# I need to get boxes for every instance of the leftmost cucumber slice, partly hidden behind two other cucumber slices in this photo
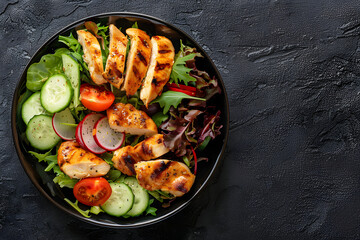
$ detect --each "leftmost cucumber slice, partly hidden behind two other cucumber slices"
[21,92,46,124]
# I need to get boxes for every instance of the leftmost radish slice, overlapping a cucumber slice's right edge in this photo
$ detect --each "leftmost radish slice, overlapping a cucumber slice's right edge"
[52,108,76,140]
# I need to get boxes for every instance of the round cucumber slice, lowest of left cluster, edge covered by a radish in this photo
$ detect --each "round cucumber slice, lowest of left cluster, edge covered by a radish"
[26,115,61,150]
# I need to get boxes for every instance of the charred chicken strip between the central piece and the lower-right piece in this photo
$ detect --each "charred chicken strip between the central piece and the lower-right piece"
[112,134,169,176]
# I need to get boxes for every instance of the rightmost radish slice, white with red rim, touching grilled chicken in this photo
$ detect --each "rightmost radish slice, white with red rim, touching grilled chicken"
[94,116,125,151]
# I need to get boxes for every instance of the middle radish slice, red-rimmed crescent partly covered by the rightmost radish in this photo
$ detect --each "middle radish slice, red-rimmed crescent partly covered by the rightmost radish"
[80,113,106,154]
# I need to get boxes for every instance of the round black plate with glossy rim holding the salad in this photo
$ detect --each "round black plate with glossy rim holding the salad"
[11,13,229,228]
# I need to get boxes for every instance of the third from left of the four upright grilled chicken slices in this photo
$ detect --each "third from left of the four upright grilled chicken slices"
[123,28,151,96]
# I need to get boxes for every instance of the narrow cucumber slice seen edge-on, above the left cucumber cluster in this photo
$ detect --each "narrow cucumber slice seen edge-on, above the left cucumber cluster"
[61,54,80,107]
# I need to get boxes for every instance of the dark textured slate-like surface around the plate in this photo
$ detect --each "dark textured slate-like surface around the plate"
[0,0,360,239]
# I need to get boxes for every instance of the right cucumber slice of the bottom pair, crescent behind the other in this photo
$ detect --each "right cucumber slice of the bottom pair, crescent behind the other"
[124,177,149,217]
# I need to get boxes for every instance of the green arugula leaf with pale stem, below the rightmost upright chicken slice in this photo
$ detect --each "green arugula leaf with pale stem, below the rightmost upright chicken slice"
[151,91,205,114]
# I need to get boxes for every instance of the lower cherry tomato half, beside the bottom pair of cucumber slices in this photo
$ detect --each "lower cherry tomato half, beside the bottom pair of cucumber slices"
[73,177,112,206]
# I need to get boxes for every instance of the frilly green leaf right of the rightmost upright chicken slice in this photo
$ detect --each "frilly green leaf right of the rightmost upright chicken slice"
[170,53,196,85]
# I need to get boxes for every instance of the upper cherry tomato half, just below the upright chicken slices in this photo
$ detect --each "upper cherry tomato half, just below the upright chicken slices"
[80,83,115,112]
